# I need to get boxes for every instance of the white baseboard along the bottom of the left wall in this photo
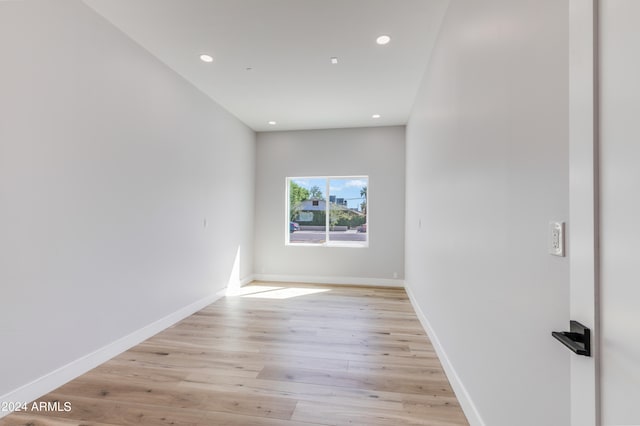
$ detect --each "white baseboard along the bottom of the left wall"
[0,288,226,418]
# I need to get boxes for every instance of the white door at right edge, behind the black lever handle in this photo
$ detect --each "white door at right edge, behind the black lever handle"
[569,0,640,426]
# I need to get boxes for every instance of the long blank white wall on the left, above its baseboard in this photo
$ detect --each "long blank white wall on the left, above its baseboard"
[0,0,255,404]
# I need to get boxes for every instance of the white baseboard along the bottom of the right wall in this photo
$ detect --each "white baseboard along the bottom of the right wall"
[405,285,486,426]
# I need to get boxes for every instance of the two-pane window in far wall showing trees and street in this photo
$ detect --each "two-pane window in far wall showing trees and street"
[286,176,369,247]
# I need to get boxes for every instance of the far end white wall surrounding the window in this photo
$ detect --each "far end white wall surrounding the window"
[255,126,405,285]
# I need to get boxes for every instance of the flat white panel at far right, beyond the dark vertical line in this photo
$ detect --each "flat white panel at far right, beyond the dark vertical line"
[599,0,640,426]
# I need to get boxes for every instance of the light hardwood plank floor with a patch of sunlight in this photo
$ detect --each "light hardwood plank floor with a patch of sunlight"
[0,283,468,426]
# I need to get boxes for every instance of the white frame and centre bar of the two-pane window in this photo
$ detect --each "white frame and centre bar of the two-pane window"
[284,175,371,248]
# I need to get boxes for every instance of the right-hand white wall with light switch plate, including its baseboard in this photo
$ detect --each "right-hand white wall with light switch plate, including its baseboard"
[406,0,571,426]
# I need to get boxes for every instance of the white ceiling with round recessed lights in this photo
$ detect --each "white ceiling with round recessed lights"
[84,0,448,131]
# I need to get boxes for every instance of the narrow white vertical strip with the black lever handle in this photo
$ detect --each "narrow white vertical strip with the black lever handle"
[568,0,601,426]
